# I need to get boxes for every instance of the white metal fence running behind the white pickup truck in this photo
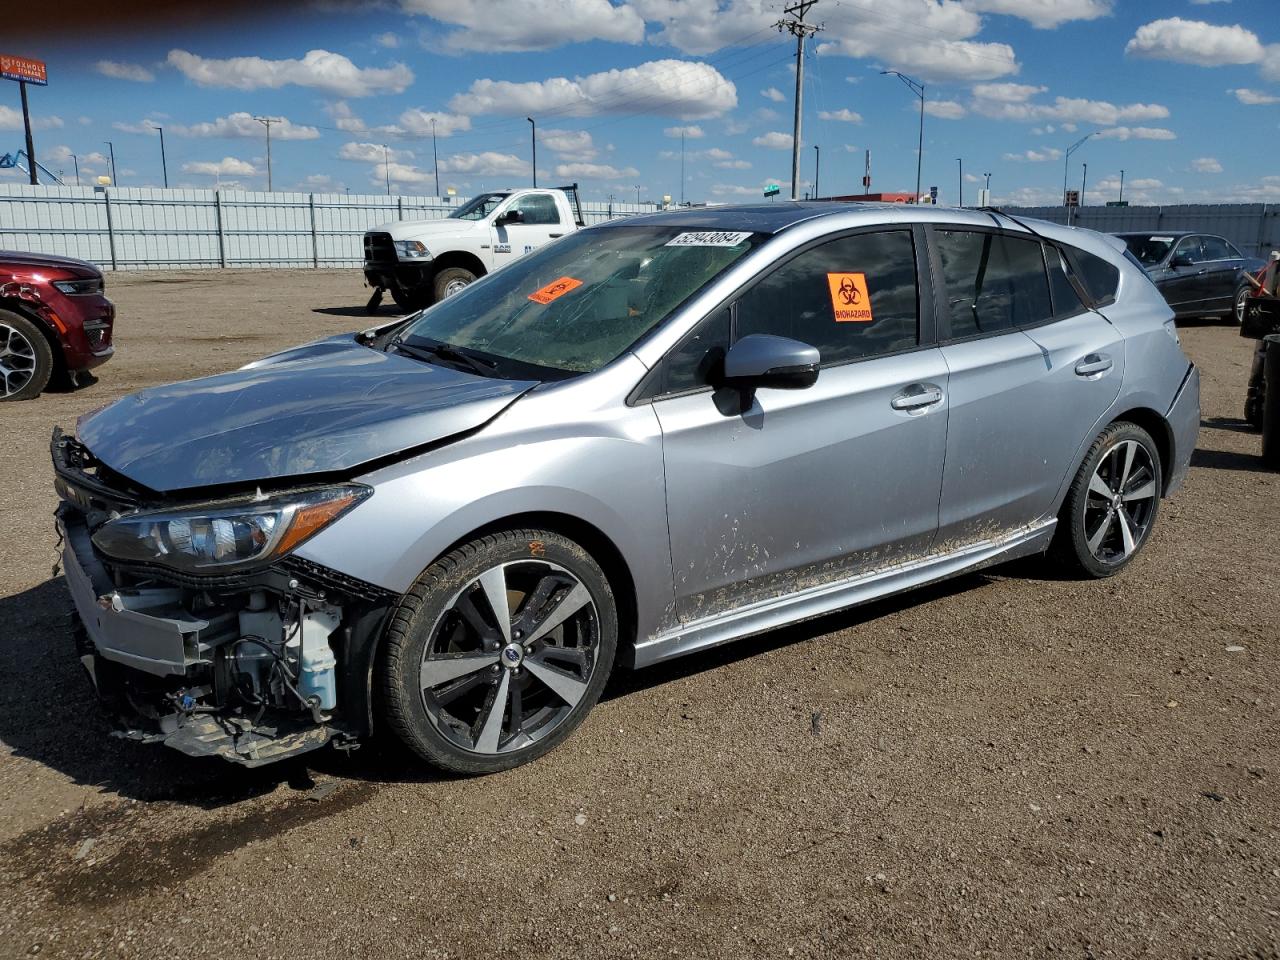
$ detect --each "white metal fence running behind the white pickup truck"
[0,183,654,270]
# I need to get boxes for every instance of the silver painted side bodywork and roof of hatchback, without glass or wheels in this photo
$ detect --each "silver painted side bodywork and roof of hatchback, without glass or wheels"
[86,204,1198,663]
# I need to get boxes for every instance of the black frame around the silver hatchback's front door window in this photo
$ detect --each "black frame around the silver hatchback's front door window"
[626,223,936,407]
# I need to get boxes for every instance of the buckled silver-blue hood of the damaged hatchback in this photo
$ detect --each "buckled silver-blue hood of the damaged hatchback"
[77,335,536,493]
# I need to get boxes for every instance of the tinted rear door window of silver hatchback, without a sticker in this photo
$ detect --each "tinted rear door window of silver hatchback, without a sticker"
[933,229,1053,339]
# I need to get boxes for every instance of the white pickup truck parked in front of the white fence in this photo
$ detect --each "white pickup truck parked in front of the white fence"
[365,183,582,314]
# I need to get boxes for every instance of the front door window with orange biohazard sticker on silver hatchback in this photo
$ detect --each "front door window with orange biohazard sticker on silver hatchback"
[736,229,919,365]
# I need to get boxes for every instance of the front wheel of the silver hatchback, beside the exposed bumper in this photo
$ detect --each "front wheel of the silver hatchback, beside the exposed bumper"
[379,530,618,773]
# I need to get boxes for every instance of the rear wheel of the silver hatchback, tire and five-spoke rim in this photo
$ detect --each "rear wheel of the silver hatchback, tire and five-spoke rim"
[1051,421,1164,577]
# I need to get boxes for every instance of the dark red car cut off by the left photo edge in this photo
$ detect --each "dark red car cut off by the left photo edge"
[0,251,115,401]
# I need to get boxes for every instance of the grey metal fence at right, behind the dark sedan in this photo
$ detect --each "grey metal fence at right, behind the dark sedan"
[1007,204,1280,257]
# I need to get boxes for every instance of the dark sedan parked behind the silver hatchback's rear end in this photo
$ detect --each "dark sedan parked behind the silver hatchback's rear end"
[1116,230,1266,323]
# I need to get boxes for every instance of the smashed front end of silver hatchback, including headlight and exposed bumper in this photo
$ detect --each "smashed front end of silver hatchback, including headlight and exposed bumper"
[51,430,396,767]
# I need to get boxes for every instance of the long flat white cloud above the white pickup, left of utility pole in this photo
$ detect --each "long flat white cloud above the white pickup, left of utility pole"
[449,60,737,119]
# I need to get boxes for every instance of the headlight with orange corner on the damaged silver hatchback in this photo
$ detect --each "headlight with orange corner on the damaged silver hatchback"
[93,484,372,573]
